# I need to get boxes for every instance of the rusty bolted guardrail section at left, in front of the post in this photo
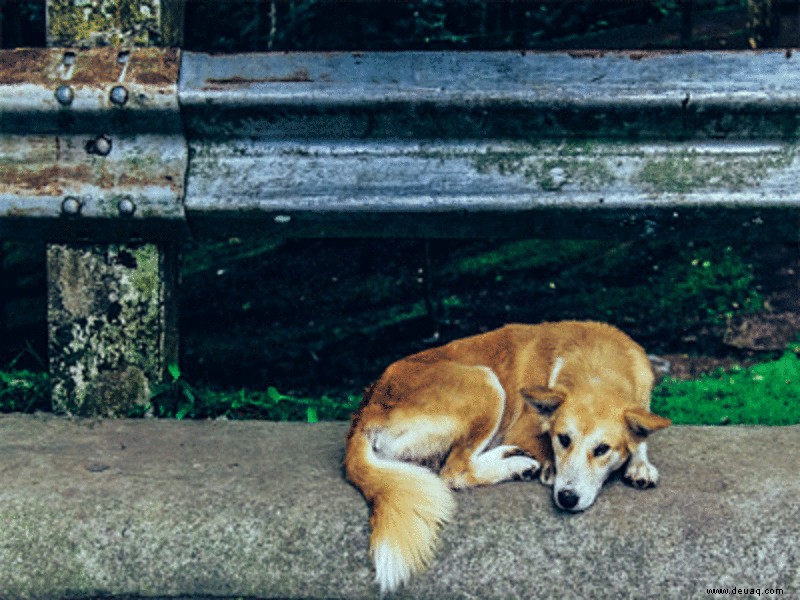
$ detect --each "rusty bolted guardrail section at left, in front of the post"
[0,48,188,242]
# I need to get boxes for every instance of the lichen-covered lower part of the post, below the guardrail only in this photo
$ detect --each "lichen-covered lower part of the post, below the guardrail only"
[47,244,177,416]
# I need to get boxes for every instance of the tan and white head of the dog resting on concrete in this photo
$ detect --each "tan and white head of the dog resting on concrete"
[521,386,671,512]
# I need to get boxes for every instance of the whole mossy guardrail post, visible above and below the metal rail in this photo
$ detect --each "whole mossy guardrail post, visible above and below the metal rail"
[47,0,183,416]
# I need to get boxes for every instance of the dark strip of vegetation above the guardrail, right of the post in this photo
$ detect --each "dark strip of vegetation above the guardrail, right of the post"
[181,0,798,52]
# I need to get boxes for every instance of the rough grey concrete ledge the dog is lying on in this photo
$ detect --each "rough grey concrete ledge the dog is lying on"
[0,416,800,599]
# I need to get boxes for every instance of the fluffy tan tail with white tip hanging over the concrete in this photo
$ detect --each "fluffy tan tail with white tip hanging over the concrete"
[345,430,455,594]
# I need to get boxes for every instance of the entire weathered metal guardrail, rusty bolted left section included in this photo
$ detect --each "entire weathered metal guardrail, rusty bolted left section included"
[0,49,800,241]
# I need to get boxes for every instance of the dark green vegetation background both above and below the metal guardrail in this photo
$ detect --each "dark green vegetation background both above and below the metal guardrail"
[0,0,800,423]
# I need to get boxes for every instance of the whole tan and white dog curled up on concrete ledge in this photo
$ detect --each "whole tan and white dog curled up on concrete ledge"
[345,321,671,594]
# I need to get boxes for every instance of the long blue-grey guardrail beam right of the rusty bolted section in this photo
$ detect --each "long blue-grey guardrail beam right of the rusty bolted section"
[179,52,800,239]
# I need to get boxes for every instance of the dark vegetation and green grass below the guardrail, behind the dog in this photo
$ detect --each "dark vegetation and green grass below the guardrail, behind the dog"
[0,239,800,424]
